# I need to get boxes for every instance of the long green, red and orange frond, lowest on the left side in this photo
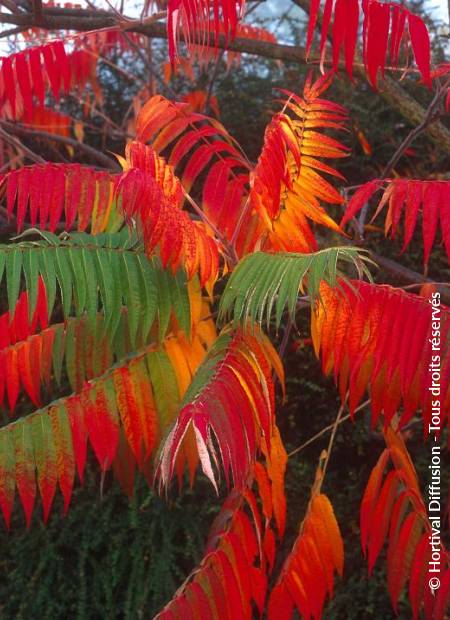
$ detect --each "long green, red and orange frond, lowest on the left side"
[0,330,216,524]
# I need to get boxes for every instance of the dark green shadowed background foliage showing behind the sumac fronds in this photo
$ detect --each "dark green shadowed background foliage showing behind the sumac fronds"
[0,2,450,620]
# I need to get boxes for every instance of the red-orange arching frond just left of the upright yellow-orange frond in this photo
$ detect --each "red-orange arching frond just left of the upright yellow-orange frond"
[136,95,257,254]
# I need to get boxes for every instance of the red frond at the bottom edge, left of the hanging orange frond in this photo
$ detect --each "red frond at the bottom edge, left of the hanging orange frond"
[155,482,275,620]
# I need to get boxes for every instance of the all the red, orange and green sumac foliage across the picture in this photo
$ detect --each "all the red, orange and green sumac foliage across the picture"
[0,0,450,620]
